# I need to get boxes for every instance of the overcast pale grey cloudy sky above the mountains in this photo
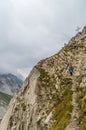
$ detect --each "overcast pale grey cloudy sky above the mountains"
[0,0,86,78]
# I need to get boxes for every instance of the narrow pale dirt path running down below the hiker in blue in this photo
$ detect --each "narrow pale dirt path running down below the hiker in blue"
[65,78,79,130]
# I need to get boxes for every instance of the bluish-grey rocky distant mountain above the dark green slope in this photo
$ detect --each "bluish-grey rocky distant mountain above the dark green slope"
[0,74,22,95]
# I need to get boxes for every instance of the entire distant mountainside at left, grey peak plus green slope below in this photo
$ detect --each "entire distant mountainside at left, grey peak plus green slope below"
[0,73,22,119]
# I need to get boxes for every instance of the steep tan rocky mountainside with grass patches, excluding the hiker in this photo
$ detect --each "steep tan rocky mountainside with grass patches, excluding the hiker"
[0,25,86,130]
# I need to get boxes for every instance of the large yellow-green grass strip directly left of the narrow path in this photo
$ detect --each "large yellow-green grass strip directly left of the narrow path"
[50,85,73,130]
